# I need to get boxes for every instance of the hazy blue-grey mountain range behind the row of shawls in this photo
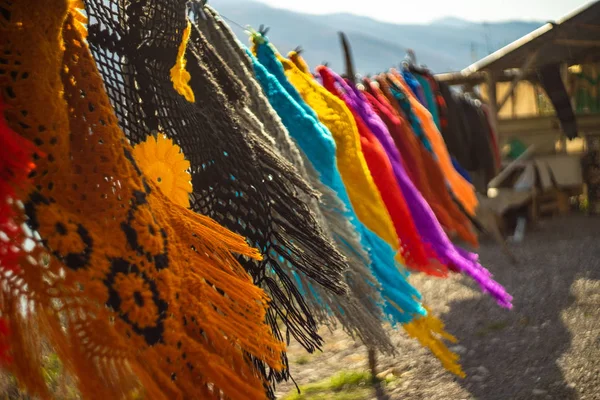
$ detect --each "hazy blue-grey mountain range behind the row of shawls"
[210,0,543,74]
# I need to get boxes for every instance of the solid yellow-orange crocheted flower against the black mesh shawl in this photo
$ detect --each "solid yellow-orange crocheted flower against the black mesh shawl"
[133,133,192,208]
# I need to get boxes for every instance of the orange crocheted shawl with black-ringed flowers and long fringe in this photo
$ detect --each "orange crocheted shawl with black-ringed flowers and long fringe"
[0,0,283,399]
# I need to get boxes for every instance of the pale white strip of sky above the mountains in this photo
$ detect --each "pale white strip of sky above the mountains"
[251,0,593,24]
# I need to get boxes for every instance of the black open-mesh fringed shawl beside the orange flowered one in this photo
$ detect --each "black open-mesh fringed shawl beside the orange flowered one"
[86,0,347,390]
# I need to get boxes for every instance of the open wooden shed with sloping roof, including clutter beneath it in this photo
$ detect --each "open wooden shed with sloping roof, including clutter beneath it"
[436,1,600,223]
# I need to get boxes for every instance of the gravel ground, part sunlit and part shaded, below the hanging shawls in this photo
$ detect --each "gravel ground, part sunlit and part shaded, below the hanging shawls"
[278,215,600,400]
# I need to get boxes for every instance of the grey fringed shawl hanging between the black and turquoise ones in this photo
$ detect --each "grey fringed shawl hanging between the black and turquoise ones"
[198,7,393,353]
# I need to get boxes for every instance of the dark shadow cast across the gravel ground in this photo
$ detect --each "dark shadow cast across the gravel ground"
[442,216,600,400]
